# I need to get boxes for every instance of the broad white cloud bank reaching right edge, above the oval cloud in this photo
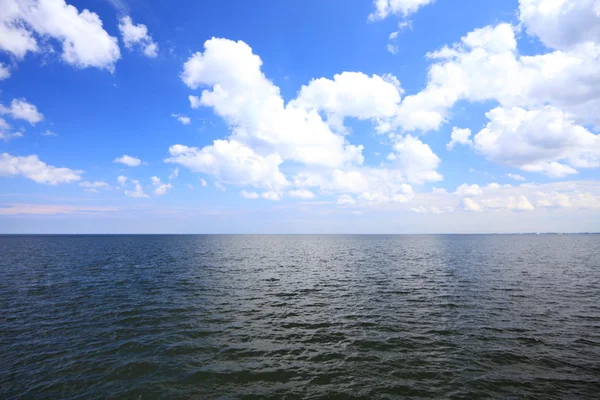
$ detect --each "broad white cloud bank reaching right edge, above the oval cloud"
[390,24,600,131]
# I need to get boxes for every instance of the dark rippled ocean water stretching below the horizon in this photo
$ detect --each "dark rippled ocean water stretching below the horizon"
[0,235,600,399]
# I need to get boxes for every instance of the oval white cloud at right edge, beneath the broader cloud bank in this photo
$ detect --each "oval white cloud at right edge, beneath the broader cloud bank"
[474,106,600,178]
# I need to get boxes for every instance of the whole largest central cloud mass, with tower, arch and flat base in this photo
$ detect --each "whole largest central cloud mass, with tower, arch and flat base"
[171,38,442,204]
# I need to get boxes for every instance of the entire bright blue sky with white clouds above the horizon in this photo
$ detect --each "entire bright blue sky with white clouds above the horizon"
[0,0,600,233]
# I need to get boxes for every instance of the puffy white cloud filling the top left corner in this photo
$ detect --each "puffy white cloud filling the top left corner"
[0,0,121,71]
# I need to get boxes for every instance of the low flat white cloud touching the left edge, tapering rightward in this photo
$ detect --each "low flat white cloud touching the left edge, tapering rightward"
[0,153,83,185]
